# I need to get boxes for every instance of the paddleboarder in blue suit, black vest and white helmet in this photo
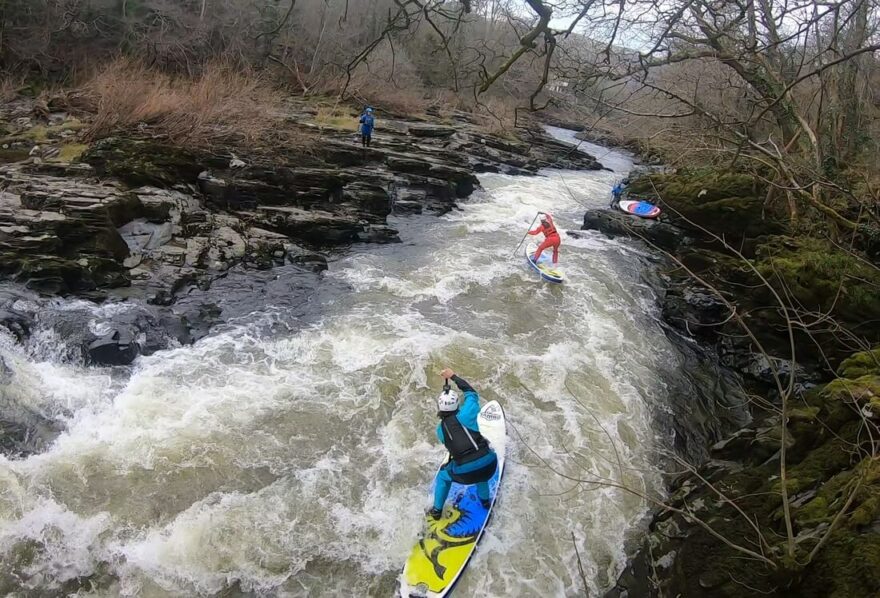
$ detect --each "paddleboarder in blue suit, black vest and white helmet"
[428,368,498,520]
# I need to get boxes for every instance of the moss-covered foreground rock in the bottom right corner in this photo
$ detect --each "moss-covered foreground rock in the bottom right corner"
[645,346,880,598]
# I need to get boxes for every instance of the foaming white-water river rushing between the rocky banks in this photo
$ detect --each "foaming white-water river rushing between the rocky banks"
[0,131,679,597]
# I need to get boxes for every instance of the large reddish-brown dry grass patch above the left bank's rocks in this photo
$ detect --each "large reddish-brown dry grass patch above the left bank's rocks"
[82,60,282,144]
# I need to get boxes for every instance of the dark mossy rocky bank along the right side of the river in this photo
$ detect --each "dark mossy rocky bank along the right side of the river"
[583,172,880,597]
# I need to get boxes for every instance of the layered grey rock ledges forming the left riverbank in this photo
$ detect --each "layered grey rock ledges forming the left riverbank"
[0,98,601,364]
